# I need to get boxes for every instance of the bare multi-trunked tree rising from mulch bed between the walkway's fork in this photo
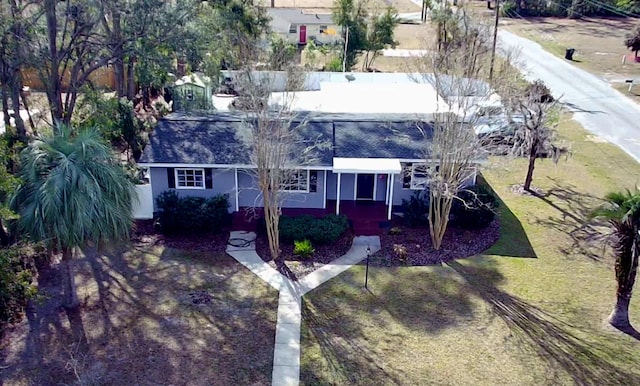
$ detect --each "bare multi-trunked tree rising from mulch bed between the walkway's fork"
[235,68,325,260]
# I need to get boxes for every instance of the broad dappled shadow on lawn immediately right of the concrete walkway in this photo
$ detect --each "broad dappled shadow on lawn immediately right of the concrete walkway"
[301,267,474,385]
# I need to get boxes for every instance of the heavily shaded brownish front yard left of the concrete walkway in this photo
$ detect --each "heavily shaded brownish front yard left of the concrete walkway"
[0,238,278,385]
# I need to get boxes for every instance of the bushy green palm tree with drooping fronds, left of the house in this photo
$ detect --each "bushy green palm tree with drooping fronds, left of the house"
[13,127,135,309]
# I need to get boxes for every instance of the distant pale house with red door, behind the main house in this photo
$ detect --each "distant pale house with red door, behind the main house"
[267,8,342,45]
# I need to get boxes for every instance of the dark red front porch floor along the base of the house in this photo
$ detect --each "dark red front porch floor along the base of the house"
[232,200,398,236]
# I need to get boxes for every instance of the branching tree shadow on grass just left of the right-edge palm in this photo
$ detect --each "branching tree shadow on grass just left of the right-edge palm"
[533,177,610,261]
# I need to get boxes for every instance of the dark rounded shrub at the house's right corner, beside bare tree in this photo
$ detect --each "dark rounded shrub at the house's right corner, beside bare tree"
[451,185,498,229]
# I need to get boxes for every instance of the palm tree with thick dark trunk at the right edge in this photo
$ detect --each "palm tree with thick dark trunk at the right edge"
[595,190,640,328]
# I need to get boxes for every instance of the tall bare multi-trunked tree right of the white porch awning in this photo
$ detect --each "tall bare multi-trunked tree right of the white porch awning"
[424,10,511,250]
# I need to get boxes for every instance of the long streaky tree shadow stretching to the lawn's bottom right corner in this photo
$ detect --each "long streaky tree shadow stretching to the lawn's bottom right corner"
[447,261,640,385]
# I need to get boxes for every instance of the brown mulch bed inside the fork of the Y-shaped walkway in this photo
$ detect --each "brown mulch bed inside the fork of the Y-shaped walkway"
[256,230,353,280]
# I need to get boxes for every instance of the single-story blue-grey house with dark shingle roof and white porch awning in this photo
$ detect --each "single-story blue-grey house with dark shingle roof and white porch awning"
[139,112,474,219]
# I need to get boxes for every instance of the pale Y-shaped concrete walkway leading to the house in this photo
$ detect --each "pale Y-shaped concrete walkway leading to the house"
[227,231,380,386]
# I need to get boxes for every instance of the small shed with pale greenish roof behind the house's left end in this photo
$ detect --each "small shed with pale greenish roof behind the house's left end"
[173,72,213,110]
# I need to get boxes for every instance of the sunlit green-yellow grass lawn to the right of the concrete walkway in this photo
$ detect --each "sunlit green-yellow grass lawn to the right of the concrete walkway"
[301,120,640,385]
